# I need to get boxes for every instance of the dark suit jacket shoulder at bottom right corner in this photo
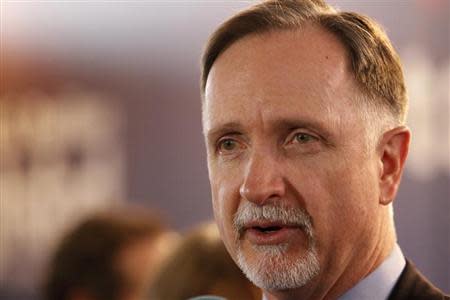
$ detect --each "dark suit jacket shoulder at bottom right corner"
[389,261,450,300]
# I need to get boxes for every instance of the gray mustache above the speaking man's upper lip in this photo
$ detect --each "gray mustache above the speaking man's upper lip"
[233,201,313,239]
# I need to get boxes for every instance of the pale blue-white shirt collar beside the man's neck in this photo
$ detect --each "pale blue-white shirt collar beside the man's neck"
[339,244,406,300]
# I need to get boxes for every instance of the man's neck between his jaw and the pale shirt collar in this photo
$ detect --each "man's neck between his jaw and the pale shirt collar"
[263,207,396,300]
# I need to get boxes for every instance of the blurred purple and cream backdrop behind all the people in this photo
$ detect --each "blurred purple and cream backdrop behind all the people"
[0,0,450,299]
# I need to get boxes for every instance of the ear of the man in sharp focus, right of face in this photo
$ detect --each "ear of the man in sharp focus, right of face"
[378,126,411,205]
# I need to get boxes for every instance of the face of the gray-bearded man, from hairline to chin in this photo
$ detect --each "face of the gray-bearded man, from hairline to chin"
[203,27,379,290]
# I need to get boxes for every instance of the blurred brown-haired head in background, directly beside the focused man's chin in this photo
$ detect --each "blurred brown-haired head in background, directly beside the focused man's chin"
[149,223,261,300]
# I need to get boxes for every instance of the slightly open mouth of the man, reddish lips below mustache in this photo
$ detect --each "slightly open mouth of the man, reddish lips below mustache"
[244,227,303,245]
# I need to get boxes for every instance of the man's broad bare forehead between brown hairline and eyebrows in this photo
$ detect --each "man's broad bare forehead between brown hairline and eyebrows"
[203,25,357,133]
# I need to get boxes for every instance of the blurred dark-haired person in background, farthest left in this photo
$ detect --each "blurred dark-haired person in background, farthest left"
[43,208,178,300]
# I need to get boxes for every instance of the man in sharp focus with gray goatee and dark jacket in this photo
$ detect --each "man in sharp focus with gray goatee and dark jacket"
[201,0,446,299]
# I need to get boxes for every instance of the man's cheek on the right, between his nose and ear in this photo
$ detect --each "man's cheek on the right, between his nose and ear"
[292,155,377,241]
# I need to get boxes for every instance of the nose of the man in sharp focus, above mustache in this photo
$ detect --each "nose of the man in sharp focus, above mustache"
[239,153,286,205]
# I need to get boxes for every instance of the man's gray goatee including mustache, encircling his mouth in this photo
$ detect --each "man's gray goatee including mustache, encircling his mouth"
[234,202,320,291]
